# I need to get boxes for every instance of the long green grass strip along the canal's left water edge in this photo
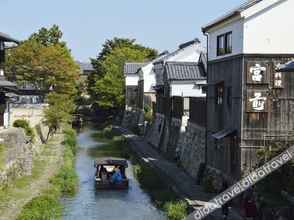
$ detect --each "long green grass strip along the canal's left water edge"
[17,126,78,220]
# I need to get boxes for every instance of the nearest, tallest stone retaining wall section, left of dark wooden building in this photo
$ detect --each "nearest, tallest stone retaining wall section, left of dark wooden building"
[178,122,205,179]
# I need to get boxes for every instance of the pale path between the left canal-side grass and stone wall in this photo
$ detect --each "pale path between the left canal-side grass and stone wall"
[0,135,63,220]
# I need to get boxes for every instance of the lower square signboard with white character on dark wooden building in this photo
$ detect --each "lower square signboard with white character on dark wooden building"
[247,90,268,112]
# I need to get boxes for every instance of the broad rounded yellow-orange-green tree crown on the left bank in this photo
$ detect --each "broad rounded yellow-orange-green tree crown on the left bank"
[6,39,79,94]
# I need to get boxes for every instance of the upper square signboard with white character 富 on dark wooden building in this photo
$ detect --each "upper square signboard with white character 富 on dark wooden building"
[247,62,271,84]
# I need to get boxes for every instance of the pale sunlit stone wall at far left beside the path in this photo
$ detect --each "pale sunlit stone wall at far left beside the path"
[0,128,33,188]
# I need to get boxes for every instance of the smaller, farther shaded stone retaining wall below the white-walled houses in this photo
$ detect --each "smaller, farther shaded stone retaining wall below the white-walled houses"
[145,113,165,149]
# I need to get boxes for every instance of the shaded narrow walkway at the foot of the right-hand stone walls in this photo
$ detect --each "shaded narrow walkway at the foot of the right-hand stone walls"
[114,127,243,220]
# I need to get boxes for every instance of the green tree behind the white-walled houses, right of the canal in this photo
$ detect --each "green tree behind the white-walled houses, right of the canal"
[88,38,157,110]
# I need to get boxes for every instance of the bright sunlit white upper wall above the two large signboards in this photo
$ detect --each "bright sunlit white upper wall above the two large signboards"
[243,0,294,54]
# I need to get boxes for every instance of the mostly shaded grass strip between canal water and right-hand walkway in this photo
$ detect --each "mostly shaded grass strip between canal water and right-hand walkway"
[89,127,187,220]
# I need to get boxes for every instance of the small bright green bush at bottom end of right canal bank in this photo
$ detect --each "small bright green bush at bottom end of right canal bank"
[164,201,188,220]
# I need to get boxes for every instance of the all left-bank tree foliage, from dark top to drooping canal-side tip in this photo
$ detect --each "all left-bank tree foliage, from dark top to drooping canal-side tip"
[6,25,79,139]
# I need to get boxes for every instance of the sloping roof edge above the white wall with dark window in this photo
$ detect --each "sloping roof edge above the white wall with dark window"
[202,0,263,33]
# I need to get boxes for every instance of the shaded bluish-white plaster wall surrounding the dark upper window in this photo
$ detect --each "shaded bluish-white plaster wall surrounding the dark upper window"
[208,19,243,60]
